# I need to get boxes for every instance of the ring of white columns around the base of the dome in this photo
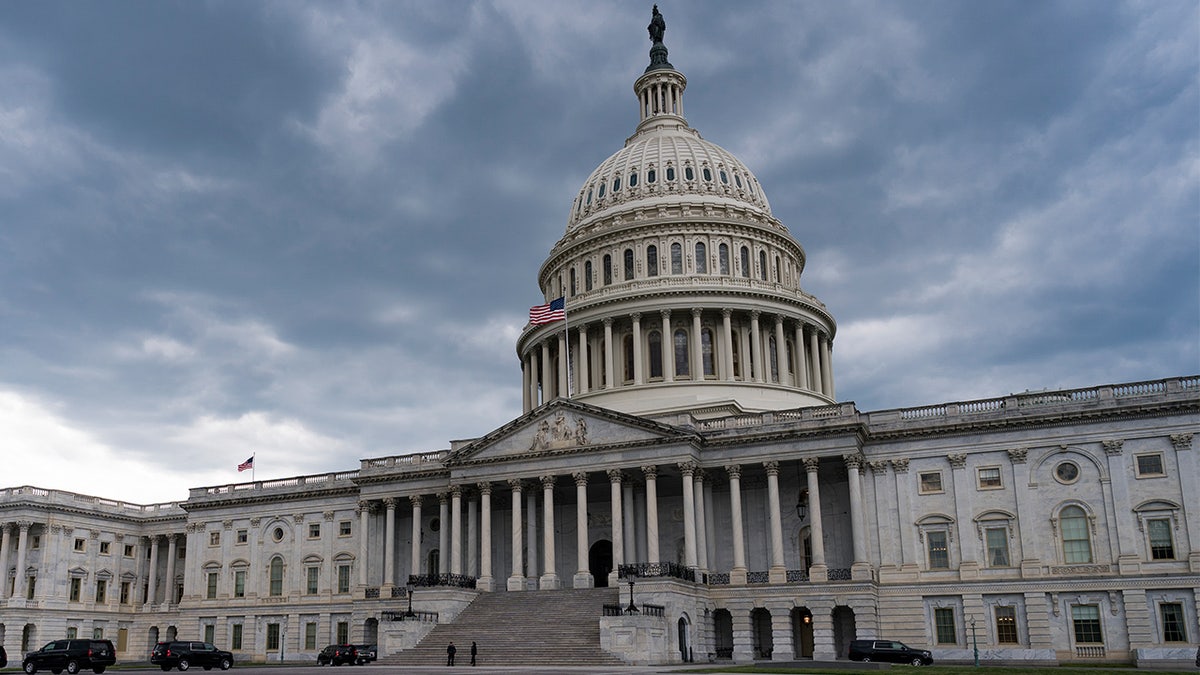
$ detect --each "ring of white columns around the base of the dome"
[521,307,836,412]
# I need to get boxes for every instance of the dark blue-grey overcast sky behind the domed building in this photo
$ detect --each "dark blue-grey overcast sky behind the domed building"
[0,0,1200,502]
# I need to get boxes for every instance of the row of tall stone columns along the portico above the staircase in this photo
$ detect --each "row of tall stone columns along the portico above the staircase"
[359,455,870,591]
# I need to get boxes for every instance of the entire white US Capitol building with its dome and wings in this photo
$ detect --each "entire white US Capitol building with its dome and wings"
[0,8,1200,665]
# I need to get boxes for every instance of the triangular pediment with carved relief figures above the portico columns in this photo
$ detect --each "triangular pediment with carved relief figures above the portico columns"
[445,399,698,465]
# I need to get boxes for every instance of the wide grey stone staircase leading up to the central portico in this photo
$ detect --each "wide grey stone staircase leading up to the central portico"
[378,589,624,665]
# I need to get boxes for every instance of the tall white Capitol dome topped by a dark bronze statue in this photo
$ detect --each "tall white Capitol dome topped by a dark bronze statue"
[517,10,836,417]
